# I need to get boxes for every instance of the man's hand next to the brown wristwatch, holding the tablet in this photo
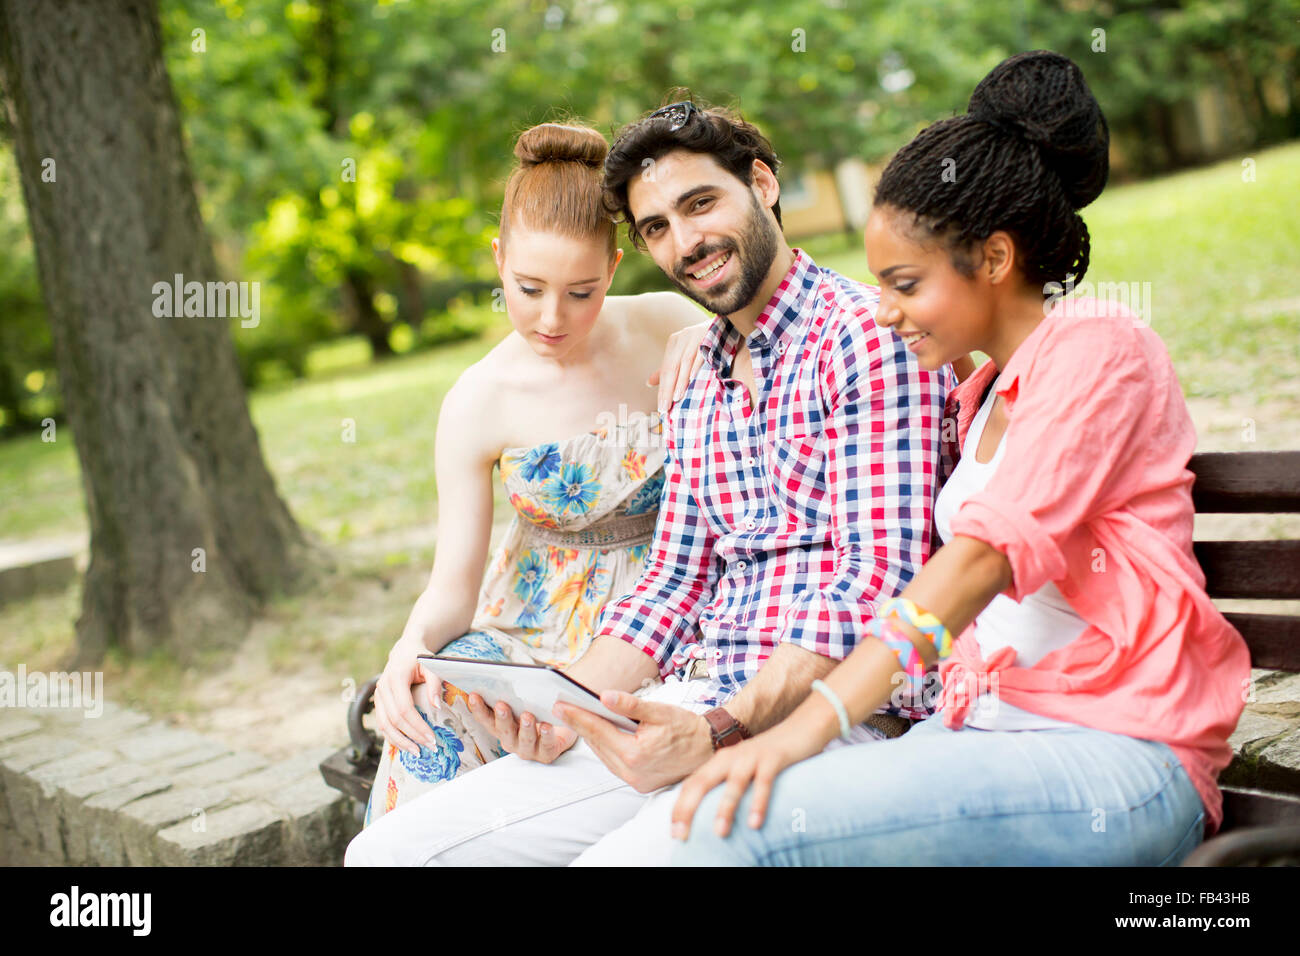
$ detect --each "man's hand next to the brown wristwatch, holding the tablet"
[555,691,714,793]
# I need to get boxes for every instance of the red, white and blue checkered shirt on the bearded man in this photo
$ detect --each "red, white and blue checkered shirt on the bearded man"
[595,250,952,717]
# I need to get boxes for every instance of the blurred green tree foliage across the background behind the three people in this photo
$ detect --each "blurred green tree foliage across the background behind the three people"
[0,0,1300,428]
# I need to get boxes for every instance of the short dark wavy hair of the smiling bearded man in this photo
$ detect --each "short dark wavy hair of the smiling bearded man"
[605,90,781,252]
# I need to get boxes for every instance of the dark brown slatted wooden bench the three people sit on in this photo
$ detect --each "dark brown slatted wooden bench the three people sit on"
[321,451,1300,866]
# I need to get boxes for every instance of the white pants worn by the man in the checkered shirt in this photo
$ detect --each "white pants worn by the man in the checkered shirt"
[343,678,876,866]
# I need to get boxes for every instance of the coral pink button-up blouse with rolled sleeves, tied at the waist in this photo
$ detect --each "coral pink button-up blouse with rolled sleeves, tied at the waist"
[940,299,1251,834]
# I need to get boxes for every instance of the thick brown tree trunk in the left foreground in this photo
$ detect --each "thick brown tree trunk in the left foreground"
[0,0,316,663]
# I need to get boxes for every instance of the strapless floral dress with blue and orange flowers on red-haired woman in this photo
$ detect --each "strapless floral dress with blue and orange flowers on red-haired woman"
[365,412,666,826]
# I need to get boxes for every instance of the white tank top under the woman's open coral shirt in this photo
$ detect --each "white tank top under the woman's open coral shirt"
[935,386,1088,730]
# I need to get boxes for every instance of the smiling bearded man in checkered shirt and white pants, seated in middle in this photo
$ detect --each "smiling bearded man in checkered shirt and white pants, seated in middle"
[347,101,952,865]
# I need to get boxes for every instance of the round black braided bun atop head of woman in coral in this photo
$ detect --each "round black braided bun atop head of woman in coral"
[967,49,1110,209]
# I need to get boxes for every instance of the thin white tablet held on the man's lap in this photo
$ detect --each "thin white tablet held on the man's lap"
[419,654,637,734]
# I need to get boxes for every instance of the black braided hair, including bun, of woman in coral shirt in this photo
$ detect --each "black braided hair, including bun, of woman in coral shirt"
[874,49,1110,295]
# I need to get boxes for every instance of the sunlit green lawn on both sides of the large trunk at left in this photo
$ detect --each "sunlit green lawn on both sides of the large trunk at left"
[0,306,508,542]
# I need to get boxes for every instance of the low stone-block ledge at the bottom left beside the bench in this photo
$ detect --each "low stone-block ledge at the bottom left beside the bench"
[0,701,360,866]
